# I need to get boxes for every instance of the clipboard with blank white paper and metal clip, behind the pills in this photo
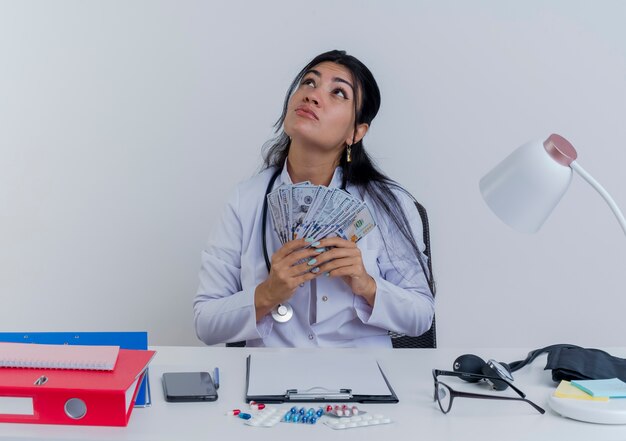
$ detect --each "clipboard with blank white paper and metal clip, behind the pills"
[246,351,399,403]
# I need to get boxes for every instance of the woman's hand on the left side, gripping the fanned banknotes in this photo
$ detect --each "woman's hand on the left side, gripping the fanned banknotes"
[254,239,320,321]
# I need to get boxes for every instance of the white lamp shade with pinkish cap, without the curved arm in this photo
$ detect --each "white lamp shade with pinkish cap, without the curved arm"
[480,134,576,233]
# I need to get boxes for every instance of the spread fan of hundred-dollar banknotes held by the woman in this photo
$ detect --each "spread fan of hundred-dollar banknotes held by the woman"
[267,181,376,244]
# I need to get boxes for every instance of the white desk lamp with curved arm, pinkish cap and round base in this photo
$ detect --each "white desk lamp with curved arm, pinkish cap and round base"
[480,134,626,424]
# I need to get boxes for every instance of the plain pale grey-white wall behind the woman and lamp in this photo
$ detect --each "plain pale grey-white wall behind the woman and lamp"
[0,0,626,347]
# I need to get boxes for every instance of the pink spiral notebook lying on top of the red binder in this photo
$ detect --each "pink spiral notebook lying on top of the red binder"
[0,343,120,371]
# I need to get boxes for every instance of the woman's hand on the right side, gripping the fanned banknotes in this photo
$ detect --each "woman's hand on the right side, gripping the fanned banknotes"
[308,237,376,306]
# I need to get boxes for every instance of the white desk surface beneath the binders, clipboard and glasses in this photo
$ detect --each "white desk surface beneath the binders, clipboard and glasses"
[0,347,626,441]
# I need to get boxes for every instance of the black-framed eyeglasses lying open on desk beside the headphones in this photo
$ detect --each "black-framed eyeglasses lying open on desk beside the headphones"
[433,369,546,414]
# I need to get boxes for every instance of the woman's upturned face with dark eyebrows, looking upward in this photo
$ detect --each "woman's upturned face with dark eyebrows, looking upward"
[284,62,364,151]
